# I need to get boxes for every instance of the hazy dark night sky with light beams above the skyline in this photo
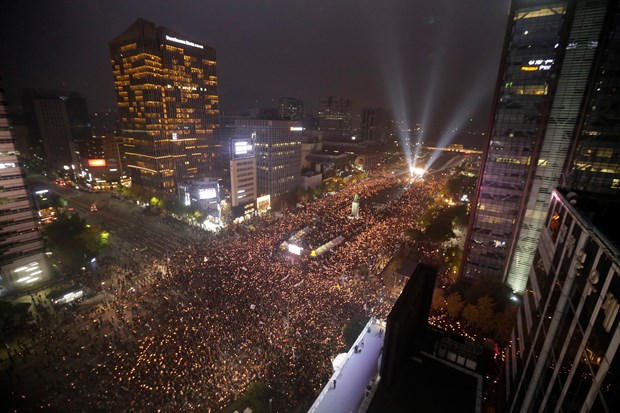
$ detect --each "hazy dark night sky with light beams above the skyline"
[0,0,509,144]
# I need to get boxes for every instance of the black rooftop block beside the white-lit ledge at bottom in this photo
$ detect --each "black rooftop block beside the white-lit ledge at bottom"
[360,263,488,413]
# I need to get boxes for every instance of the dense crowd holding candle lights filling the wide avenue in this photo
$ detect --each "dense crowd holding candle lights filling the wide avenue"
[2,172,448,412]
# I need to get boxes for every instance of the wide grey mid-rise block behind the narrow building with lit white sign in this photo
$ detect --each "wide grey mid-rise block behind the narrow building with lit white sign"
[235,119,303,198]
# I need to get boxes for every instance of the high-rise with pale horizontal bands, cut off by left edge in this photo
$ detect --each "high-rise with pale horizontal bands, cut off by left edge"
[0,77,50,295]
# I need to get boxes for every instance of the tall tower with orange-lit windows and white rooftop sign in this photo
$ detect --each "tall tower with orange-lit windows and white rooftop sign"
[110,19,221,191]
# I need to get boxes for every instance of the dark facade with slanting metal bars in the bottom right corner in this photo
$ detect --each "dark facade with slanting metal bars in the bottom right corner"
[504,190,620,412]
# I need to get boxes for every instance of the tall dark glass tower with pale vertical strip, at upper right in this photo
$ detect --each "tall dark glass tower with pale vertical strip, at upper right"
[461,0,620,292]
